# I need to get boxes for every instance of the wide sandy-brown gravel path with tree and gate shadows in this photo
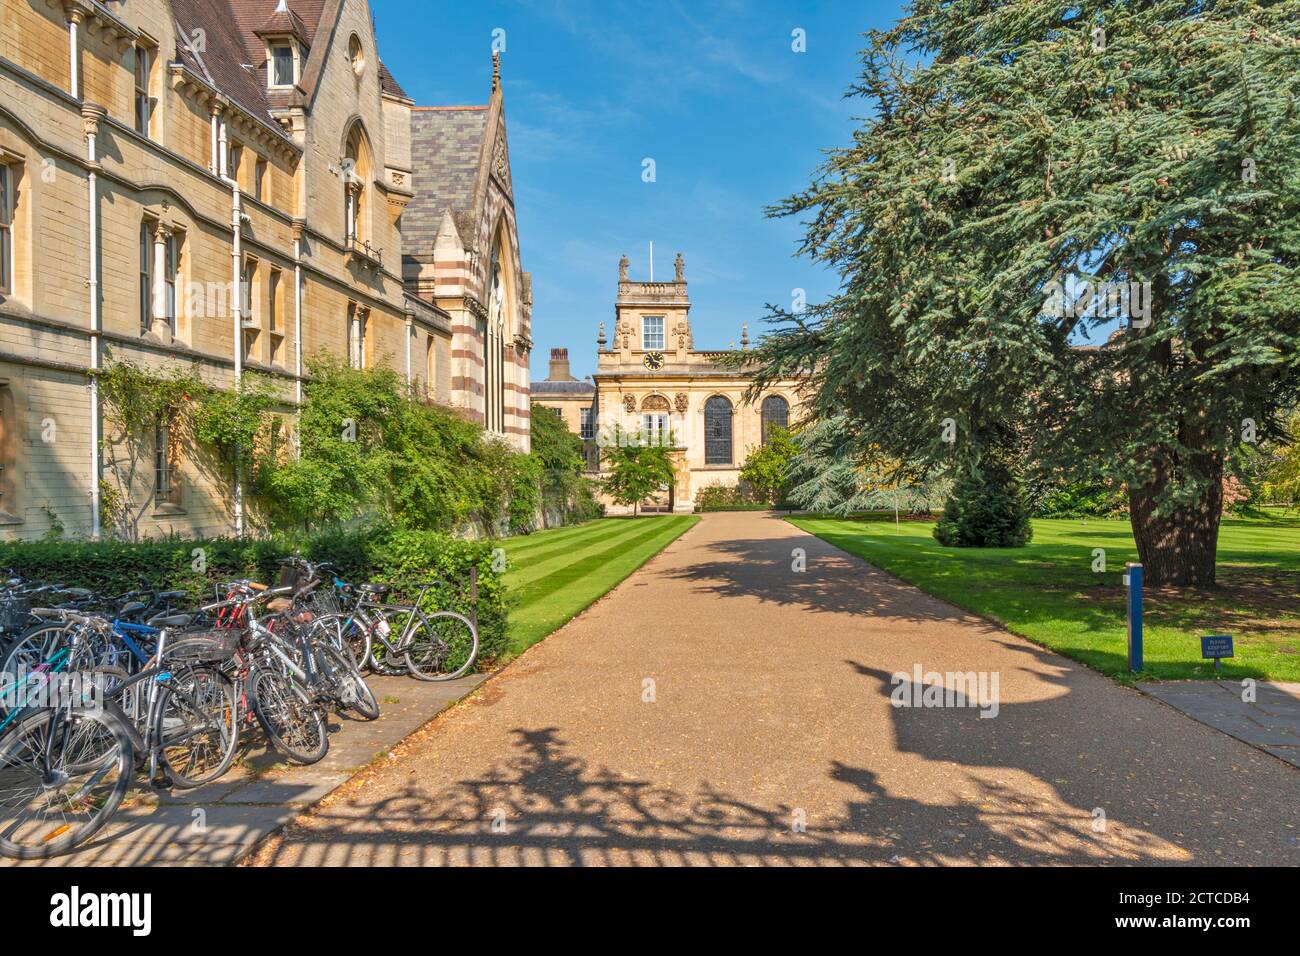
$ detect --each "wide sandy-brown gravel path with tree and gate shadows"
[252,512,1300,866]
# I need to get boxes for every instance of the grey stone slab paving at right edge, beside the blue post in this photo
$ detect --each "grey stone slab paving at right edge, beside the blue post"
[1139,680,1300,767]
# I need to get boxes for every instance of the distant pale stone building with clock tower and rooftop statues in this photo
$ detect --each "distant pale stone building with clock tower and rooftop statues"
[533,254,801,514]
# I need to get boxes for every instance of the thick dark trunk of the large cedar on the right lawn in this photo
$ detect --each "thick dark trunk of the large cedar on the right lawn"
[1128,460,1223,588]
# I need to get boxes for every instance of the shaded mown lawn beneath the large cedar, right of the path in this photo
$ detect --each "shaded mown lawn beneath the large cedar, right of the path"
[790,515,1300,680]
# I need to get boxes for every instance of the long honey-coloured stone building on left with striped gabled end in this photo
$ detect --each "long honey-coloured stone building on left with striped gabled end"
[0,0,529,537]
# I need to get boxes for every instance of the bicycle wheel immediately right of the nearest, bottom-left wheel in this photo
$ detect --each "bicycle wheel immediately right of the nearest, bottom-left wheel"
[153,667,239,790]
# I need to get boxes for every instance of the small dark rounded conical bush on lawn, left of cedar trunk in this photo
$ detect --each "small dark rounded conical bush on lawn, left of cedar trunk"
[935,462,1034,548]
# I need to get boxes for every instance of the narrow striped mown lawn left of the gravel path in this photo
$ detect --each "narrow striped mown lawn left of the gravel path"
[503,515,699,657]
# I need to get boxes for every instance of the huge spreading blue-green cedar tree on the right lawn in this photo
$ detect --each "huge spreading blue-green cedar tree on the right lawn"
[746,0,1300,585]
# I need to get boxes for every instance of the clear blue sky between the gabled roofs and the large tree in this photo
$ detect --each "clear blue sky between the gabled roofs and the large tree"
[372,0,901,378]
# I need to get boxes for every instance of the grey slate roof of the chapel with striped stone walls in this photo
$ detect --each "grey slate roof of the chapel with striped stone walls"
[402,107,488,258]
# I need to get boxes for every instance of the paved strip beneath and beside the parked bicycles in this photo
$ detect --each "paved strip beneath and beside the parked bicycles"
[0,674,484,866]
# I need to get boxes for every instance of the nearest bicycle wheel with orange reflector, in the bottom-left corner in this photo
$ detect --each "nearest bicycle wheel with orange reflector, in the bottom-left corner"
[0,710,135,860]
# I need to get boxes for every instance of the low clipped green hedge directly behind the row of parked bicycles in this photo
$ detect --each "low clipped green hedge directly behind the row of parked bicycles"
[0,527,507,665]
